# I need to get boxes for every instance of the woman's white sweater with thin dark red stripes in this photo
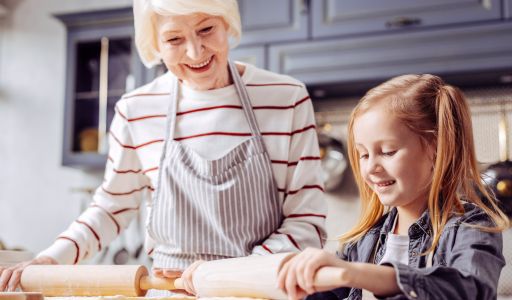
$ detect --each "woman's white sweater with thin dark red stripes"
[39,65,327,264]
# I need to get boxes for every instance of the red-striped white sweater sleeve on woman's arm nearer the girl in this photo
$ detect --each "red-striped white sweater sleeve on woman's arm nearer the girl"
[252,87,327,254]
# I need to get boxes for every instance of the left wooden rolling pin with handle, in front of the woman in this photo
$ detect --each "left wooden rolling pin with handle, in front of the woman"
[20,265,176,296]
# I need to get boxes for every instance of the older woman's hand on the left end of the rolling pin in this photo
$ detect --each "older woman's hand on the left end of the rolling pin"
[0,256,57,292]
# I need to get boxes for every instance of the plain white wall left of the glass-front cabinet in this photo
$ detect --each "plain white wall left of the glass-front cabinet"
[0,0,131,252]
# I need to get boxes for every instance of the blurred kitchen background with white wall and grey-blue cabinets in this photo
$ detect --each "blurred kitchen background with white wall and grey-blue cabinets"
[0,0,512,297]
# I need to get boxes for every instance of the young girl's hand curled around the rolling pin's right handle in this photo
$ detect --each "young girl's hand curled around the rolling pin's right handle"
[277,248,350,300]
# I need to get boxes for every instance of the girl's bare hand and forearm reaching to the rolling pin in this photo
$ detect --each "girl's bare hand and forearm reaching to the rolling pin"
[278,248,400,299]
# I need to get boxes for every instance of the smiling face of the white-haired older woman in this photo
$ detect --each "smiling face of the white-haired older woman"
[157,13,230,90]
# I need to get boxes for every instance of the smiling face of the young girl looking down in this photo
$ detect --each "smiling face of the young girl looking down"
[353,101,434,212]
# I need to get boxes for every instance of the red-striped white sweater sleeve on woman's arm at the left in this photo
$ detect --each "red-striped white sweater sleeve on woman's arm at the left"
[38,100,153,264]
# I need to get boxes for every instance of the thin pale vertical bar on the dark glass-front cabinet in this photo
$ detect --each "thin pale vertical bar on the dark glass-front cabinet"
[98,37,109,154]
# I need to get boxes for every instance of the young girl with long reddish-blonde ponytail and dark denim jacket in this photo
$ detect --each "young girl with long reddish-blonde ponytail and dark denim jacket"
[278,74,509,299]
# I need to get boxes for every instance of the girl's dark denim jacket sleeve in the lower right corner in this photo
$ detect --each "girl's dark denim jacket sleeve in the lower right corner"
[382,213,505,300]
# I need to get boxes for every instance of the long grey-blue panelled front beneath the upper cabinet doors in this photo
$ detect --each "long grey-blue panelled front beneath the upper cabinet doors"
[269,22,512,88]
